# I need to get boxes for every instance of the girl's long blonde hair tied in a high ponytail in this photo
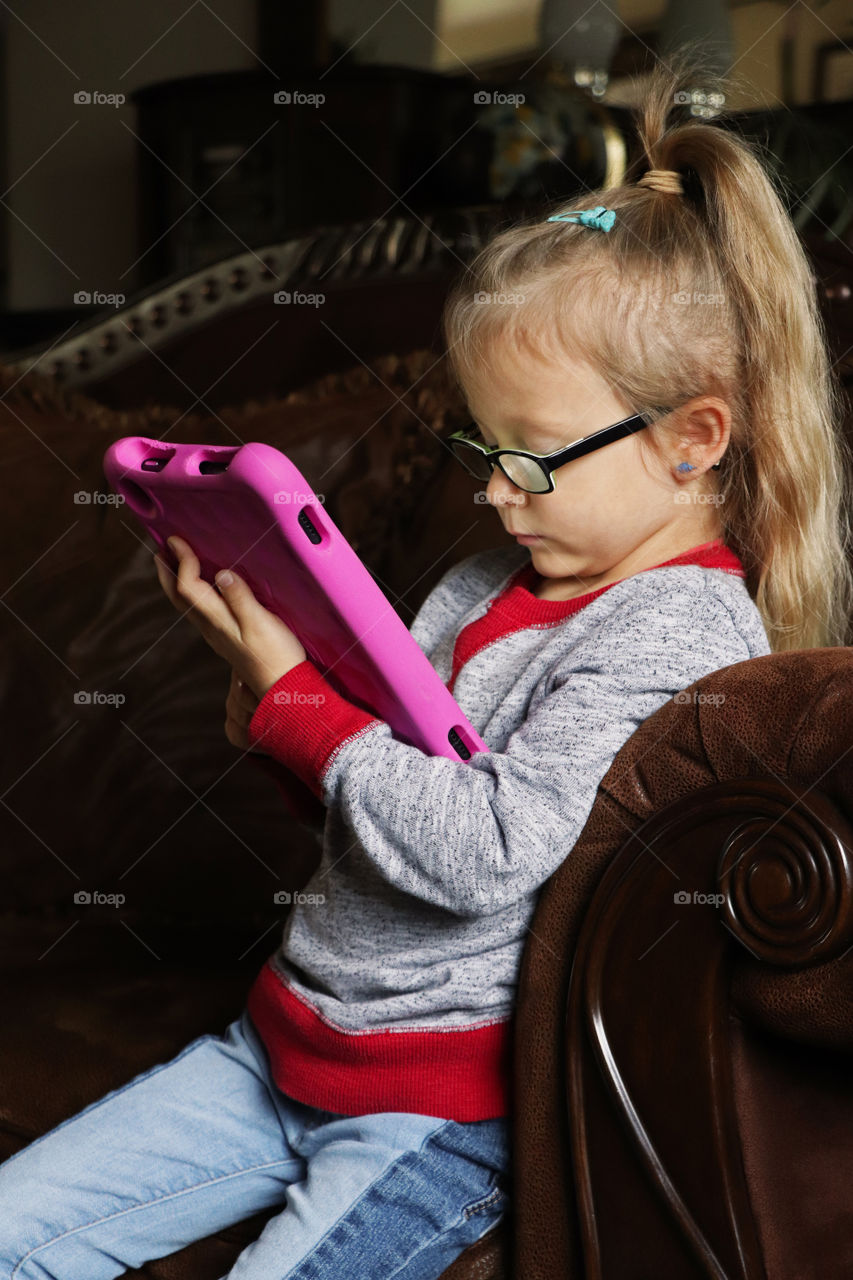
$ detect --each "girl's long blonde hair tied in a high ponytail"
[442,47,853,652]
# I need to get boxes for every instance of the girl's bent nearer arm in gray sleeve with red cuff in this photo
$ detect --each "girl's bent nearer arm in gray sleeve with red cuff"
[248,575,751,915]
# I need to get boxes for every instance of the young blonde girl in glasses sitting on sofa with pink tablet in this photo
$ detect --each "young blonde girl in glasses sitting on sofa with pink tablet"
[0,49,852,1280]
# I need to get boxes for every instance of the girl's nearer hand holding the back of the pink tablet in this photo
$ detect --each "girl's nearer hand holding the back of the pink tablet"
[154,535,307,700]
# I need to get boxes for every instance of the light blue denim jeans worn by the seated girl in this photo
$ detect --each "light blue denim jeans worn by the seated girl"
[0,1010,510,1280]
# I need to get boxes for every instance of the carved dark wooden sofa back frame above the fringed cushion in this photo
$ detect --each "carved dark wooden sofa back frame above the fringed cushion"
[4,200,853,409]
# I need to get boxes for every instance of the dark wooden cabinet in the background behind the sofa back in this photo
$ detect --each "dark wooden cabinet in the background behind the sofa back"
[131,63,499,285]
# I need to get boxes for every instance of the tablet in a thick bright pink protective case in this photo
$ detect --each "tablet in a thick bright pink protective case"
[104,435,488,760]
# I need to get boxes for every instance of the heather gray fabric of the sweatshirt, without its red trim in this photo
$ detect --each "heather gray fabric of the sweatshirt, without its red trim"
[266,547,770,1030]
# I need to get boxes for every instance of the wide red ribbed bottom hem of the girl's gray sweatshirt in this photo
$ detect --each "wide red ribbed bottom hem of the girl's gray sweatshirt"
[247,957,511,1121]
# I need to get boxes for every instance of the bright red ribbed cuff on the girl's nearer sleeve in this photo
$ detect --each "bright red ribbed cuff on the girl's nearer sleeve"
[248,658,383,799]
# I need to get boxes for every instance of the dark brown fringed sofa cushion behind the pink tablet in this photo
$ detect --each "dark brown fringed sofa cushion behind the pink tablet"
[0,352,506,952]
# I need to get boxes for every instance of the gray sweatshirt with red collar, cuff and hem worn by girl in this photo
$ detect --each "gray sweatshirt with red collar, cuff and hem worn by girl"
[242,540,770,1120]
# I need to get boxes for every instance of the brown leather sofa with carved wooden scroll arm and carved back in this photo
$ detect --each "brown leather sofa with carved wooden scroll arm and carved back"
[0,210,853,1280]
